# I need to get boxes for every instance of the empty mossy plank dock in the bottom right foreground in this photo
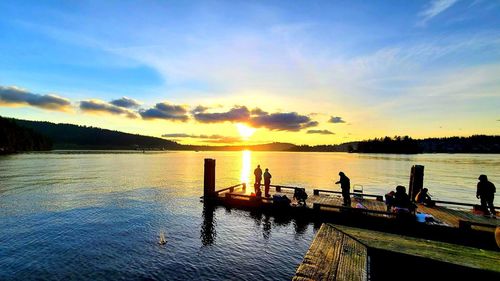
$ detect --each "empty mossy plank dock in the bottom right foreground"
[293,224,500,281]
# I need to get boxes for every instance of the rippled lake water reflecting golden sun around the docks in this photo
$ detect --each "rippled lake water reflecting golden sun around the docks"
[0,151,500,280]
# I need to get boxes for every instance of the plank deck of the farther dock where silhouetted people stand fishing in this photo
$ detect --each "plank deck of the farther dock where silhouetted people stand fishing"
[209,184,500,232]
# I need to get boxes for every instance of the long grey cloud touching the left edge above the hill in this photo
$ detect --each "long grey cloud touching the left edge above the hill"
[0,86,71,111]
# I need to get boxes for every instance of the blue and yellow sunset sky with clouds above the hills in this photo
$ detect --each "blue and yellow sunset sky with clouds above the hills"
[0,0,500,145]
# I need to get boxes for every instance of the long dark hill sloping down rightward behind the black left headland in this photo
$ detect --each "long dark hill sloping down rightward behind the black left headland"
[10,119,182,150]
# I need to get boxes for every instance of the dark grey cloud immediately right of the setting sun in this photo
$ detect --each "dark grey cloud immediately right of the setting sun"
[248,112,318,131]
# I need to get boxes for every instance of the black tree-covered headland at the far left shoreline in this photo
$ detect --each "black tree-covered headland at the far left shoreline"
[0,116,52,154]
